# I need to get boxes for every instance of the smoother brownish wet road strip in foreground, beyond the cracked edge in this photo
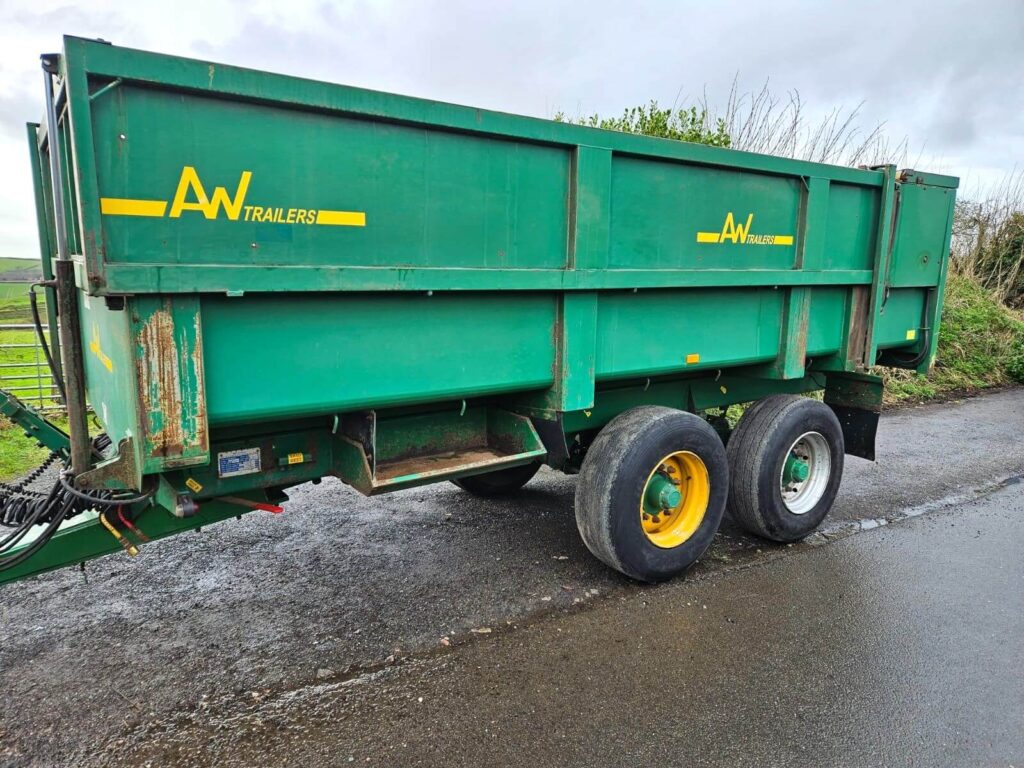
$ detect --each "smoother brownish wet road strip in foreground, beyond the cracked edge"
[97,475,1024,768]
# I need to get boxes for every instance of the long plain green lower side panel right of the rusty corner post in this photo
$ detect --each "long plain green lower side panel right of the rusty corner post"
[195,293,557,425]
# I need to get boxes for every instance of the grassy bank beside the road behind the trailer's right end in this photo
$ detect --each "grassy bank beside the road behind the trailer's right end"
[883,275,1024,403]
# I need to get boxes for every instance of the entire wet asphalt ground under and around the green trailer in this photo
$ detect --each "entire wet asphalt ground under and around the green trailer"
[0,390,1024,766]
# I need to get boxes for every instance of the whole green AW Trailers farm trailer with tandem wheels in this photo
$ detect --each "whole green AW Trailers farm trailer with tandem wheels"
[0,38,957,581]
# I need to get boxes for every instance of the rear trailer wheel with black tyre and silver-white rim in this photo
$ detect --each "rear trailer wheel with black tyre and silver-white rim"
[727,394,845,542]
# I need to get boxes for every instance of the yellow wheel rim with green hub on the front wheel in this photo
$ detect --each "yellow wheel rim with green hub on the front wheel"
[640,451,711,549]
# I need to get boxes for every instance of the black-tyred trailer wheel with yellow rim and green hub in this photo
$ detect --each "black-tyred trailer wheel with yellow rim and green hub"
[575,406,729,582]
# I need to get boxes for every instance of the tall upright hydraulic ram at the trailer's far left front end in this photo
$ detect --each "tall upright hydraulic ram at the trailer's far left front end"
[42,54,91,475]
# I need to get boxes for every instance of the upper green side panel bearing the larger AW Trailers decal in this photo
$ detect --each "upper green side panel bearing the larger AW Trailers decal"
[92,86,570,268]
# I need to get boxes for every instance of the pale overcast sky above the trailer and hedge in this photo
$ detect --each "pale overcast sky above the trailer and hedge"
[0,0,1024,257]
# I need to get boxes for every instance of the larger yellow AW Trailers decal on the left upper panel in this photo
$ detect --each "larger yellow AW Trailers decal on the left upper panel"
[99,165,367,226]
